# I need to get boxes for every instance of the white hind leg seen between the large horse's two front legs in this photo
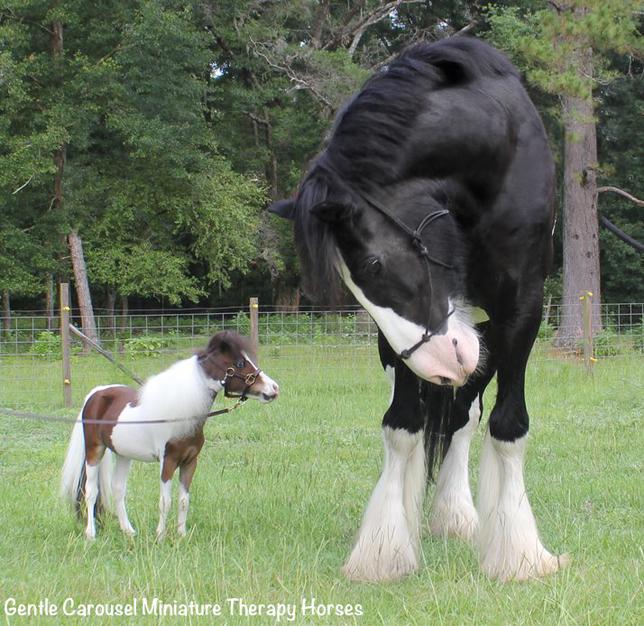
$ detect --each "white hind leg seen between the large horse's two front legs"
[429,396,481,541]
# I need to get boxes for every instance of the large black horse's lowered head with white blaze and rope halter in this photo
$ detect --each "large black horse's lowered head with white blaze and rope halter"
[271,176,479,386]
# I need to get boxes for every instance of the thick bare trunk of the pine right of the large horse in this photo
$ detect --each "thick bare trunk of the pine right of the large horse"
[556,40,601,348]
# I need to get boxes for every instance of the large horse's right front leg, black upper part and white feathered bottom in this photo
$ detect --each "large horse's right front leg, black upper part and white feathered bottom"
[477,301,567,581]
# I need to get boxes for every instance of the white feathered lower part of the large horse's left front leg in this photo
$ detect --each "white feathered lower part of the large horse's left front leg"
[343,426,425,582]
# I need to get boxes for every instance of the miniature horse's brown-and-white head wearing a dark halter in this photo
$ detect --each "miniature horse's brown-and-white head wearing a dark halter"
[197,330,279,402]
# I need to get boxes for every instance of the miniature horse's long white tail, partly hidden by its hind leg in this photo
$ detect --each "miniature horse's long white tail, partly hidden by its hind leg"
[60,405,113,517]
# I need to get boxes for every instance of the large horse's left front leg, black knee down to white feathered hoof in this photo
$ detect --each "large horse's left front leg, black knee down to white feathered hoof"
[343,342,425,582]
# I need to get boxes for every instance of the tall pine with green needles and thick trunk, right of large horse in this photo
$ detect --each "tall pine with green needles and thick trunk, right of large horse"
[488,0,638,346]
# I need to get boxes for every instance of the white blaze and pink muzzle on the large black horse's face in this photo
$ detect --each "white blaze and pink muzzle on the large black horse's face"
[339,264,479,387]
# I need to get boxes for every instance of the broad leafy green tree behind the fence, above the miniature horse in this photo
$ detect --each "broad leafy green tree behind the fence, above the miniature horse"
[0,0,265,312]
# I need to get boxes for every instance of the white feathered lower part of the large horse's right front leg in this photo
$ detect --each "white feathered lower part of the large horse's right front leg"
[477,429,568,581]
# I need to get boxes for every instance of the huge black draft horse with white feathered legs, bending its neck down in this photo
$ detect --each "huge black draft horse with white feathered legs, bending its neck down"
[269,37,565,581]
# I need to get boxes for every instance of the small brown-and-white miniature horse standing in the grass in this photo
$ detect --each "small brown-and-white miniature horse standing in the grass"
[61,331,279,539]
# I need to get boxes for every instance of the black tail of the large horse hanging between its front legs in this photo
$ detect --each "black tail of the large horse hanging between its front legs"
[418,380,454,481]
